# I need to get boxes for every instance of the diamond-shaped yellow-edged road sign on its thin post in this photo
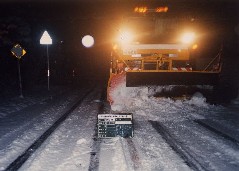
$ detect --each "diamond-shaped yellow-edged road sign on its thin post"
[11,44,26,98]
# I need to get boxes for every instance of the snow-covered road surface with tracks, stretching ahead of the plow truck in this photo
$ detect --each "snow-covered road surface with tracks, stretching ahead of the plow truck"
[0,87,239,171]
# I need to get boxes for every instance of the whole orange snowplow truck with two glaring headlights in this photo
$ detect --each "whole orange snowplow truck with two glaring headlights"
[107,8,222,104]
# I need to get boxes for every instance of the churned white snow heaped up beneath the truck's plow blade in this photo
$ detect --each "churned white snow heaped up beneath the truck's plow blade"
[111,83,209,112]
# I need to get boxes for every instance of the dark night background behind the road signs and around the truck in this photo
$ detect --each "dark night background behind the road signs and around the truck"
[0,0,239,93]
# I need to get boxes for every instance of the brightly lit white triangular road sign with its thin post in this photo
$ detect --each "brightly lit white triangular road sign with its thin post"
[40,31,52,90]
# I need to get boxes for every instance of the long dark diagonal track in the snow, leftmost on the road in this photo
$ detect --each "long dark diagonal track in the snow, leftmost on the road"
[5,87,94,171]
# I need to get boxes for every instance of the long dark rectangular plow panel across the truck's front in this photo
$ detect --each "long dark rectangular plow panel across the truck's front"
[126,71,219,87]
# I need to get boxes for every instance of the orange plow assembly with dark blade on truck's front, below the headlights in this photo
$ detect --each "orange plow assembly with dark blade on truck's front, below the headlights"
[108,44,221,104]
